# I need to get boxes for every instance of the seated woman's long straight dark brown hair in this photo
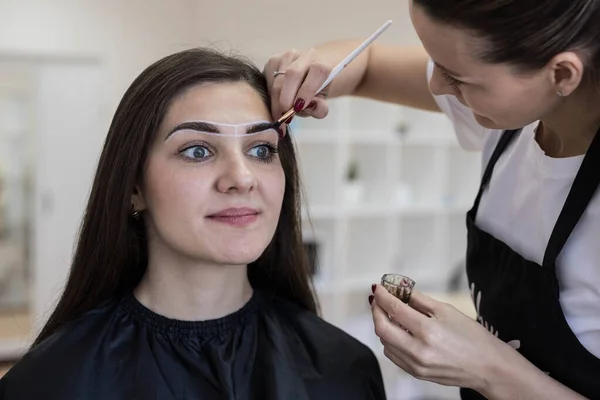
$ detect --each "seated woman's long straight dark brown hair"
[34,49,317,346]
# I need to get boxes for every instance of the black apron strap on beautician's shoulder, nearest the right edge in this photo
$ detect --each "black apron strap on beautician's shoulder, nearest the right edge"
[542,129,600,272]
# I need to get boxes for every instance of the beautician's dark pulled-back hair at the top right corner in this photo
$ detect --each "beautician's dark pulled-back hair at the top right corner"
[413,0,600,82]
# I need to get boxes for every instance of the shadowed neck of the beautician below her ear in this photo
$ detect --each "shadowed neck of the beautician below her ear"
[536,88,600,158]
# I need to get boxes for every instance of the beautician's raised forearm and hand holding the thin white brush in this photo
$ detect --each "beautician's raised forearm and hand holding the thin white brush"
[264,40,440,118]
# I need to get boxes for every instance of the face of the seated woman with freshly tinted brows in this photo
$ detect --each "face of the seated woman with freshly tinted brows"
[134,83,285,265]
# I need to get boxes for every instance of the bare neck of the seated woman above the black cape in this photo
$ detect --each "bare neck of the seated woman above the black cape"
[134,239,252,321]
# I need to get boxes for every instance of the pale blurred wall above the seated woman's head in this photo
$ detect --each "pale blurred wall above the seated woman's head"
[0,0,418,116]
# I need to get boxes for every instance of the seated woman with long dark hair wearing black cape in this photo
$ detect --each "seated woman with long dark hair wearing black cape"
[0,49,385,400]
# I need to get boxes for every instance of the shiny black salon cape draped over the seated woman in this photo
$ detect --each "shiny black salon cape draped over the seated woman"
[0,291,385,400]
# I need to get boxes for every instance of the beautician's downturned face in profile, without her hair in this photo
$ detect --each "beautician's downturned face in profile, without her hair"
[410,1,559,129]
